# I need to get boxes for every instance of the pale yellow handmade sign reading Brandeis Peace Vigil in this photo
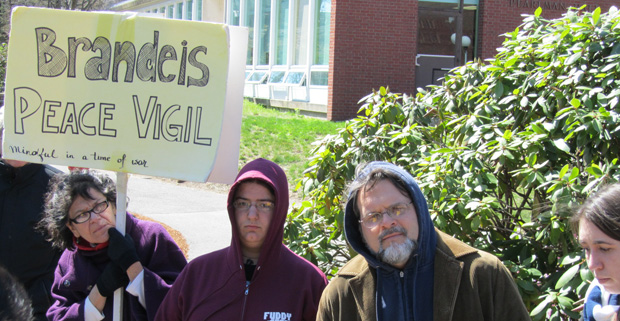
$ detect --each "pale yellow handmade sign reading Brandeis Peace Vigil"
[3,7,247,181]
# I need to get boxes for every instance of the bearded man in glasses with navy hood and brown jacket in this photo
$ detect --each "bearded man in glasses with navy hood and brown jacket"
[317,162,530,321]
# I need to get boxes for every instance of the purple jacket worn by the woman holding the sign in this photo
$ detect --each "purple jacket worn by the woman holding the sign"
[47,213,187,320]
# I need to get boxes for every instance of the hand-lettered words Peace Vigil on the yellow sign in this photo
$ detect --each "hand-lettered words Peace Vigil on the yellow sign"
[13,87,212,146]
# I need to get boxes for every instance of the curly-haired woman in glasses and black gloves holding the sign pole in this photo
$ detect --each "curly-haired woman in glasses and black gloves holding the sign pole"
[40,171,187,320]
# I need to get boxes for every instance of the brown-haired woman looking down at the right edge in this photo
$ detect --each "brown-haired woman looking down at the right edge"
[571,184,620,321]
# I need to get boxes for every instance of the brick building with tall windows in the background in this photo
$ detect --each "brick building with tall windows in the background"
[113,0,615,120]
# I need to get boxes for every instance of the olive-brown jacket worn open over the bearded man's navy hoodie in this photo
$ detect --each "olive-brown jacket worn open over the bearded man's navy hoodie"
[317,230,531,321]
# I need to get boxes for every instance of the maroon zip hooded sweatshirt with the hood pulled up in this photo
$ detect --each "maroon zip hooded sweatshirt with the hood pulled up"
[155,159,327,321]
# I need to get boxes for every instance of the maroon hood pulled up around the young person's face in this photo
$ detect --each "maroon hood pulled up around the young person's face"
[227,158,289,266]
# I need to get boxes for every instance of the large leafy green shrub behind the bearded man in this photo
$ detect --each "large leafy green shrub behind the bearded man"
[285,8,620,320]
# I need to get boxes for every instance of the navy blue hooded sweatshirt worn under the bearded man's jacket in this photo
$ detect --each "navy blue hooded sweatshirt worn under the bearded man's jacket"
[344,161,437,320]
